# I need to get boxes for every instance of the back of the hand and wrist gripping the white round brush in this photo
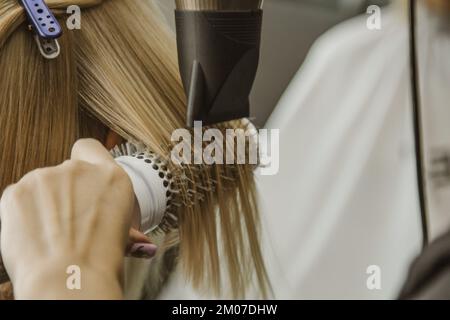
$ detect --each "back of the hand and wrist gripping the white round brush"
[0,140,134,299]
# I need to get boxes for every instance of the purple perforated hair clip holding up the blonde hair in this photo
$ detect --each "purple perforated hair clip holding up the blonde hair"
[20,0,62,59]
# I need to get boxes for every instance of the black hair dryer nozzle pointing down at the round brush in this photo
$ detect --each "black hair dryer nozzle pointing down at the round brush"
[175,10,263,127]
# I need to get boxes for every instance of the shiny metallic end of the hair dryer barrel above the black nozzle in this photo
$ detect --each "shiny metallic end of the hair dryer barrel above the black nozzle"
[176,0,263,11]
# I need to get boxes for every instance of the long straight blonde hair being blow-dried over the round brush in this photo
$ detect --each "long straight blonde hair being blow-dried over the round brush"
[0,0,268,297]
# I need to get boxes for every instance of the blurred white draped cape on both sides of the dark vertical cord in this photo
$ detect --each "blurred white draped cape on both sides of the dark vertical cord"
[259,2,450,299]
